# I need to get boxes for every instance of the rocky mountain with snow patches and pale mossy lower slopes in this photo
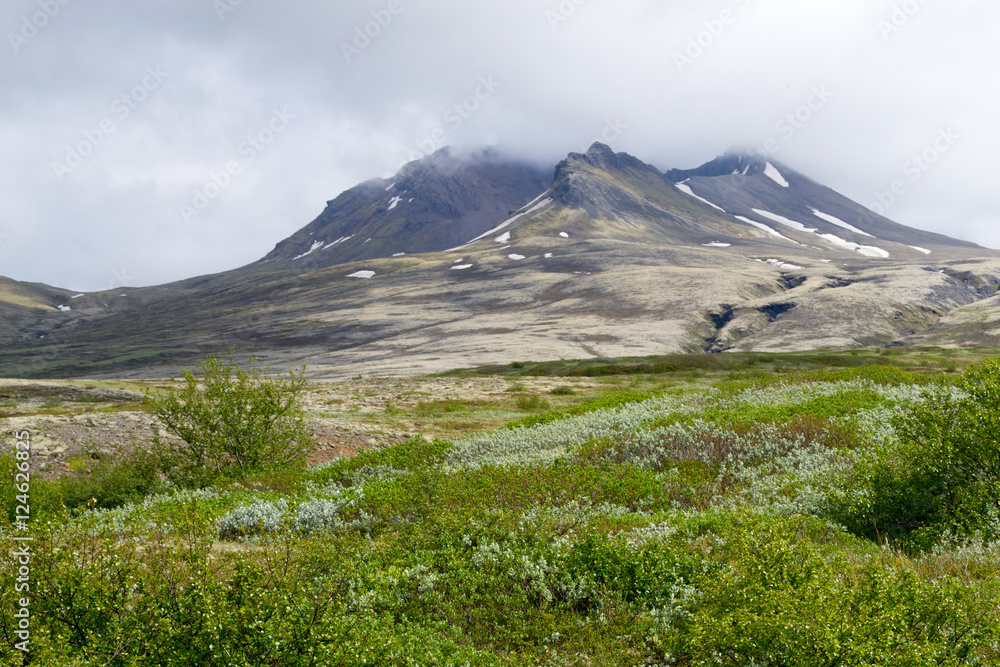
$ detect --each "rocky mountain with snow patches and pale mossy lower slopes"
[0,144,1000,377]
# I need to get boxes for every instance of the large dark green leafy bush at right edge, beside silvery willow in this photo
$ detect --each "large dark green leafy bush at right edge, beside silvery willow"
[832,361,1000,549]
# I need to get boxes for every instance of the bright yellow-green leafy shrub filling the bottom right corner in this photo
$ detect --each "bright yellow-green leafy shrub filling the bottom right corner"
[667,517,998,667]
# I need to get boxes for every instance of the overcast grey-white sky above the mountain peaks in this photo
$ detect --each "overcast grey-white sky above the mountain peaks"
[0,0,1000,291]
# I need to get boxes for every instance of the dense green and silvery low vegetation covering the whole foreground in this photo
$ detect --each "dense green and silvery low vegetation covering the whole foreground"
[0,352,1000,667]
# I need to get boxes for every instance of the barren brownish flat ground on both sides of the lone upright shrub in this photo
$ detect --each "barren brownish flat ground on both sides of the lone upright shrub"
[0,377,596,477]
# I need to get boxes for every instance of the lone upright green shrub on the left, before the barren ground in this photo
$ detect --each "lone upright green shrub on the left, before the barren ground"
[145,355,313,485]
